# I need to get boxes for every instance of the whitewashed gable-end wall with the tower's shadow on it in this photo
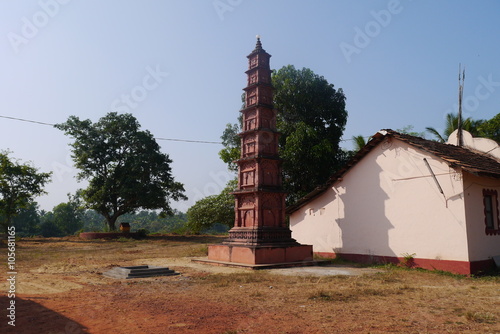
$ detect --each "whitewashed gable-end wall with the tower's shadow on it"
[290,139,469,261]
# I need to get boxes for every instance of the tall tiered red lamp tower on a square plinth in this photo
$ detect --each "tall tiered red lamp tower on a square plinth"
[208,36,312,265]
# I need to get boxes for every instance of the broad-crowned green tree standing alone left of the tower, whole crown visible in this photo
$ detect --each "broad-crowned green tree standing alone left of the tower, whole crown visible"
[56,112,187,231]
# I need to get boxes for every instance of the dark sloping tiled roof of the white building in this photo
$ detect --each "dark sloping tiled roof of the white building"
[286,129,500,214]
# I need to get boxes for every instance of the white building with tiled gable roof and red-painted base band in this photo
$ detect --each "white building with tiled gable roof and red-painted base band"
[287,130,500,274]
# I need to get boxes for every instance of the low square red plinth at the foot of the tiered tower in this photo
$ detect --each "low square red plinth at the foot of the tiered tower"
[208,244,313,265]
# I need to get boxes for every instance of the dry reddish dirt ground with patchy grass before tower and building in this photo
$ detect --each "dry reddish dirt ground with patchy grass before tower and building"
[0,236,500,334]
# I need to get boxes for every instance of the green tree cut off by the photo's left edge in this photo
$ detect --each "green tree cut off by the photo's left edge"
[0,152,51,231]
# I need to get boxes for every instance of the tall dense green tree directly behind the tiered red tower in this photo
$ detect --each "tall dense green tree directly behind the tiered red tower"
[219,65,348,203]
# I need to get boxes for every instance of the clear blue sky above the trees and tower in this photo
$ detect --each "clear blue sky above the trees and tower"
[0,0,500,212]
